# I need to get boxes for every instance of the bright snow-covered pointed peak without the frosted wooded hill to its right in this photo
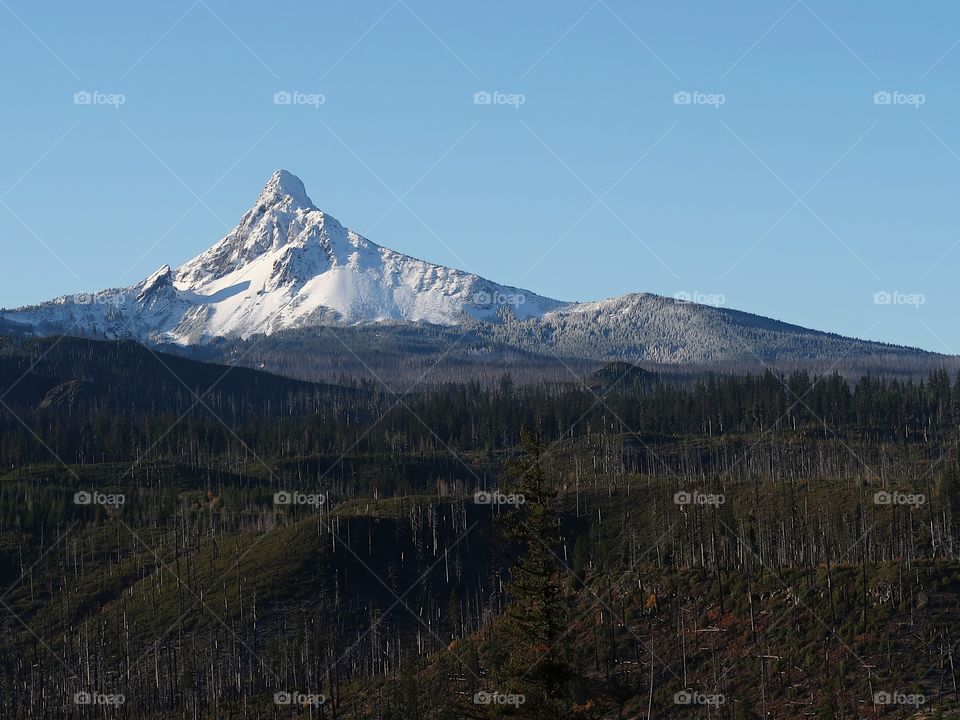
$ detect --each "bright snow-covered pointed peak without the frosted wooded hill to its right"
[0,170,568,344]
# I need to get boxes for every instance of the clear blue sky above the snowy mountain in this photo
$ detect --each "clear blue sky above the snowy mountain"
[0,0,960,352]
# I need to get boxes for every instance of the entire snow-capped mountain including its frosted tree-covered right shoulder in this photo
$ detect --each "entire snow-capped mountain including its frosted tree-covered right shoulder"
[0,170,944,363]
